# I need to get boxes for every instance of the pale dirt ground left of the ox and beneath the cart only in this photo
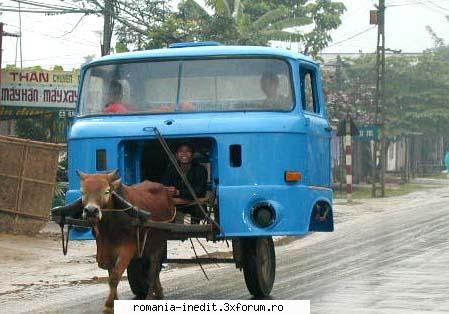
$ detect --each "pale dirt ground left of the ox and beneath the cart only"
[0,217,238,312]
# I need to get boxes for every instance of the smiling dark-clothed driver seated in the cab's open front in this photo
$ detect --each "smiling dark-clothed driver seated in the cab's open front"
[161,142,207,224]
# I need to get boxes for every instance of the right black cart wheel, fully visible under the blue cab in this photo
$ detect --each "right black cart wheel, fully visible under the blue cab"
[240,237,276,298]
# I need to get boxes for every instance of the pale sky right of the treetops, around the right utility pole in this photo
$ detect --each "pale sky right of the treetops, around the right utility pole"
[323,0,449,53]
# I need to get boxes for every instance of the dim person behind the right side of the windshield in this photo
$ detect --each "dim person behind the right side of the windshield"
[260,72,291,109]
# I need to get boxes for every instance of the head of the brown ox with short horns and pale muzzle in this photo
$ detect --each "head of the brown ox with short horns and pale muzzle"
[77,170,121,224]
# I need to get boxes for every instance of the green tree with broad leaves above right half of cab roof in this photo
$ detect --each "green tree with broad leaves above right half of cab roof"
[173,0,345,56]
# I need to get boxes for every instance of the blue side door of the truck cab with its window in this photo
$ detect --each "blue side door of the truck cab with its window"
[300,63,332,187]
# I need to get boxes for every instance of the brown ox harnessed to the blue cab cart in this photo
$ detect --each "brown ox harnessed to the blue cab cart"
[78,171,175,310]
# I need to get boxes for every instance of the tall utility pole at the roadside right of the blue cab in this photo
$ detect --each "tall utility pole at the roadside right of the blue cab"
[371,0,386,197]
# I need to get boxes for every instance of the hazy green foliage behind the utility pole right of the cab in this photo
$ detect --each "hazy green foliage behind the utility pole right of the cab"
[329,47,449,136]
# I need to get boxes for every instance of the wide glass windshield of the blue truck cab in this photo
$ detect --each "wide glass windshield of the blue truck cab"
[79,59,293,114]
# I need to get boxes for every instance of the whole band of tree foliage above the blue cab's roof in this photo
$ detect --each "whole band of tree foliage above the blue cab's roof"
[72,0,345,56]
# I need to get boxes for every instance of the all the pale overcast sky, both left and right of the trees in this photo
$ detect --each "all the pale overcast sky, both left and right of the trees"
[0,0,449,70]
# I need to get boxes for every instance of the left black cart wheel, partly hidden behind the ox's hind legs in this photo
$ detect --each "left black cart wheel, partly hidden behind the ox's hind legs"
[127,258,150,300]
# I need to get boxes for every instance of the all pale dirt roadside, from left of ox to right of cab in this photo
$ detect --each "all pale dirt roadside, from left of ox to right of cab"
[0,181,449,313]
